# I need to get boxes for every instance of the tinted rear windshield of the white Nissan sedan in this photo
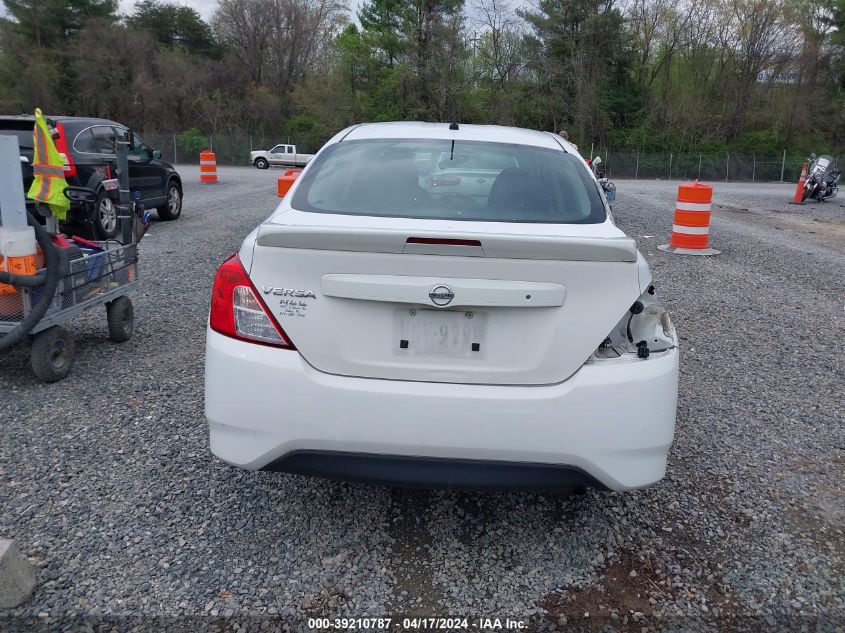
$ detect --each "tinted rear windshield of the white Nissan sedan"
[291,139,606,224]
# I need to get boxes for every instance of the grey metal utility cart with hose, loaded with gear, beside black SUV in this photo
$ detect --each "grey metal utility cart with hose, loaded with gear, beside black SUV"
[0,130,146,382]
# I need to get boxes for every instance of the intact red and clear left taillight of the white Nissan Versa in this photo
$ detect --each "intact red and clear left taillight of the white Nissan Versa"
[209,253,296,349]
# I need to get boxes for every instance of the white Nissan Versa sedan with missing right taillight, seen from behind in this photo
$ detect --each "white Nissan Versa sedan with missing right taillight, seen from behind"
[205,123,678,490]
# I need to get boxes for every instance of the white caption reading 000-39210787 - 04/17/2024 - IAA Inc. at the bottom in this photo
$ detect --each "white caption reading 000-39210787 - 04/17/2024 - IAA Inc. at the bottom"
[308,617,525,631]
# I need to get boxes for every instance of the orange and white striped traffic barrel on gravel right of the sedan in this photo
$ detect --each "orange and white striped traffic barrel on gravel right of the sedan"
[657,180,719,255]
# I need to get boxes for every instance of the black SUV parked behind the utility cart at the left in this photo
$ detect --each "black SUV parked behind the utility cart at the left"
[0,116,182,239]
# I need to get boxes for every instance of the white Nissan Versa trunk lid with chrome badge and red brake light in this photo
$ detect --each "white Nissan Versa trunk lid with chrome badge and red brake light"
[250,212,639,385]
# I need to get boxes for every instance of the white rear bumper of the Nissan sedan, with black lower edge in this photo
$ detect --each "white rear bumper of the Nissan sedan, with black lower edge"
[205,330,678,490]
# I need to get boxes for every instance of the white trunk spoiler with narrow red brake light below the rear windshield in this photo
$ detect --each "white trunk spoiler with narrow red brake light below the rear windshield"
[256,224,637,262]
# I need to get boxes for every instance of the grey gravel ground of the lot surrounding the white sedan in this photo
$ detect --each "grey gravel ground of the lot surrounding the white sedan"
[0,167,845,632]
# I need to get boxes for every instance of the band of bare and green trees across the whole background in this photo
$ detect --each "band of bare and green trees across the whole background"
[0,0,845,155]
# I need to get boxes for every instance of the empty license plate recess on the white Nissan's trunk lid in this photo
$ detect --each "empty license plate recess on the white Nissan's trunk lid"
[393,309,487,358]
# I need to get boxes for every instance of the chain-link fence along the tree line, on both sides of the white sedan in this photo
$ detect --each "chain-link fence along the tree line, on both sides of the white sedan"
[140,131,803,182]
